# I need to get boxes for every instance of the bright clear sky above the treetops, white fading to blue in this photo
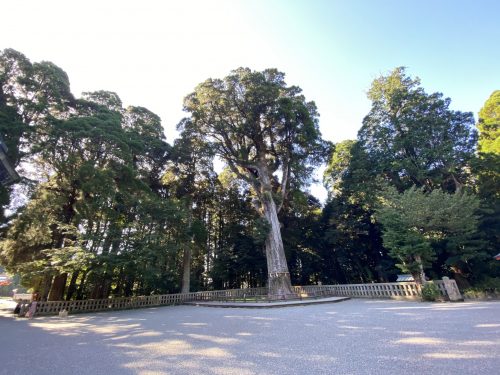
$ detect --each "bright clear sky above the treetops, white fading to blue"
[0,0,500,200]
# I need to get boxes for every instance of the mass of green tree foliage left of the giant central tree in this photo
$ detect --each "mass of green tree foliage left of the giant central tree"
[0,50,183,298]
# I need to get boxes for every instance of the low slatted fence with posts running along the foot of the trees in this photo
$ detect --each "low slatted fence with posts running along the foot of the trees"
[14,280,458,315]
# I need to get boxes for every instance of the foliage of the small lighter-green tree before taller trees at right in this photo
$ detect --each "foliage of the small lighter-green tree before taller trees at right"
[376,187,484,282]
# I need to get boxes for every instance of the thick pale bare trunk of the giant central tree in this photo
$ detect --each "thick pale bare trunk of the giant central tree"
[261,192,297,299]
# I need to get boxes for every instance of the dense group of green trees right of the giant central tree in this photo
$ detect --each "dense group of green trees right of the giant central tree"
[324,68,500,288]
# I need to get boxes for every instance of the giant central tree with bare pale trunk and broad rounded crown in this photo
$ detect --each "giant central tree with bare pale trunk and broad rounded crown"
[179,68,324,298]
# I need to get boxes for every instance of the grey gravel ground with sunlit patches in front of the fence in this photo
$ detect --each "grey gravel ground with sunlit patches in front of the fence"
[0,299,500,375]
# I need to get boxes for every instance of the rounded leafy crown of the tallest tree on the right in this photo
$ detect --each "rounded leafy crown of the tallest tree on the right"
[358,68,477,192]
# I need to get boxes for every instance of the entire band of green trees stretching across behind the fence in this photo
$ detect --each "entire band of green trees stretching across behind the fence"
[0,49,500,300]
